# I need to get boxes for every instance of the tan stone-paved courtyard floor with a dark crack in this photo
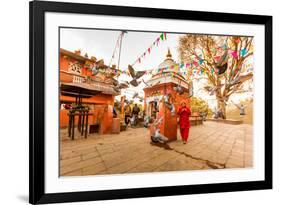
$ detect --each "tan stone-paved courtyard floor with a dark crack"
[60,122,253,176]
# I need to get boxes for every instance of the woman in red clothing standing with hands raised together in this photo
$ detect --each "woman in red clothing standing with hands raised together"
[178,101,191,144]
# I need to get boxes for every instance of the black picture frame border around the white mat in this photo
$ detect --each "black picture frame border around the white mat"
[29,1,272,204]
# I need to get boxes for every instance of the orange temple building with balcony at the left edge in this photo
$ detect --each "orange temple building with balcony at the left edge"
[59,48,120,134]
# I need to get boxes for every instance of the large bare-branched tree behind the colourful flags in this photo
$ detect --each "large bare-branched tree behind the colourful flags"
[178,34,253,118]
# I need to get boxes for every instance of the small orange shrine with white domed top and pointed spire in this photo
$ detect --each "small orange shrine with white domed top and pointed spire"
[144,49,192,141]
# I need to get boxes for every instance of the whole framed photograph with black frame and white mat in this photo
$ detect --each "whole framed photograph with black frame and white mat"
[29,1,272,204]
